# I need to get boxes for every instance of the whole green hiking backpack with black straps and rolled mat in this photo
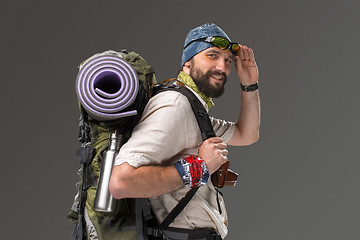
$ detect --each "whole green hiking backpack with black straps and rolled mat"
[68,50,229,240]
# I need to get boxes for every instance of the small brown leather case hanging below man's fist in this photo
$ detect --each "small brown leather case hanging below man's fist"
[211,161,238,188]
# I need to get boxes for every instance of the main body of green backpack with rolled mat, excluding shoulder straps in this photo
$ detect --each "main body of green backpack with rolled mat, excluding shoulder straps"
[68,50,156,240]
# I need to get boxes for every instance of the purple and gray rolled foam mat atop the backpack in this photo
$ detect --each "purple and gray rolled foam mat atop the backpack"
[76,51,139,121]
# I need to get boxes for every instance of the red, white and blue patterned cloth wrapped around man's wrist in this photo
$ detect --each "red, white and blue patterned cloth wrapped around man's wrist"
[174,155,209,187]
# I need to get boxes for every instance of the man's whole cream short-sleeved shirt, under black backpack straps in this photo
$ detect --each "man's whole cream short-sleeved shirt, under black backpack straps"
[115,87,235,238]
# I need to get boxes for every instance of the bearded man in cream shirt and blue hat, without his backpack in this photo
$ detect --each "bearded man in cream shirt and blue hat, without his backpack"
[110,24,260,238]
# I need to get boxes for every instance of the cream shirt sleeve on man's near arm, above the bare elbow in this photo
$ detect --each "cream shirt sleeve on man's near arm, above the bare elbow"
[115,91,195,168]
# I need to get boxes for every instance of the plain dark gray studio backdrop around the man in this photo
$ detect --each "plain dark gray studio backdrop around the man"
[0,0,360,240]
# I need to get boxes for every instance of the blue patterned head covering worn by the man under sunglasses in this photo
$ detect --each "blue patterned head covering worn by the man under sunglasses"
[181,23,231,66]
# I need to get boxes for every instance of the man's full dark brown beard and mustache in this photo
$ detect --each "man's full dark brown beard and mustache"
[190,69,227,98]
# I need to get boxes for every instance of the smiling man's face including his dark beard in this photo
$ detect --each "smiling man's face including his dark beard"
[188,47,233,98]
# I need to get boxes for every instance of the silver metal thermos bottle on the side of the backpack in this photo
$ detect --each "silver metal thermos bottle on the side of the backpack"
[94,133,122,212]
